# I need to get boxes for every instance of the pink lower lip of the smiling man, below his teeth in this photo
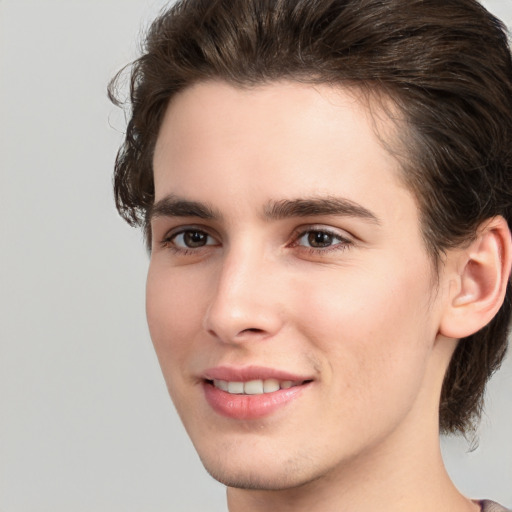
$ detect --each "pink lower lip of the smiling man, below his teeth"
[203,382,310,420]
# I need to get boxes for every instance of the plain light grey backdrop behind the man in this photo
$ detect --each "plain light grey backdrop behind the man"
[0,0,512,512]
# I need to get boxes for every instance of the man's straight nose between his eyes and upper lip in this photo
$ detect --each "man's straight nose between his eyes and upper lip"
[204,246,284,343]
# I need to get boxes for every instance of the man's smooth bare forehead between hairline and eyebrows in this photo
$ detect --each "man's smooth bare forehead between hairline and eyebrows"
[154,82,416,232]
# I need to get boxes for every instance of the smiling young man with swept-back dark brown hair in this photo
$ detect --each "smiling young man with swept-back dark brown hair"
[111,0,512,512]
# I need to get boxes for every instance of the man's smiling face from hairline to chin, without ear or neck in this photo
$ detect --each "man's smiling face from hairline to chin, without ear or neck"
[147,82,448,489]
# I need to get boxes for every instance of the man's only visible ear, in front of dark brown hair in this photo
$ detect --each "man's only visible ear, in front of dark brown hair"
[439,216,512,339]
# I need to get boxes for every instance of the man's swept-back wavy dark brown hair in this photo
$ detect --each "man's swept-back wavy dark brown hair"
[109,0,512,432]
